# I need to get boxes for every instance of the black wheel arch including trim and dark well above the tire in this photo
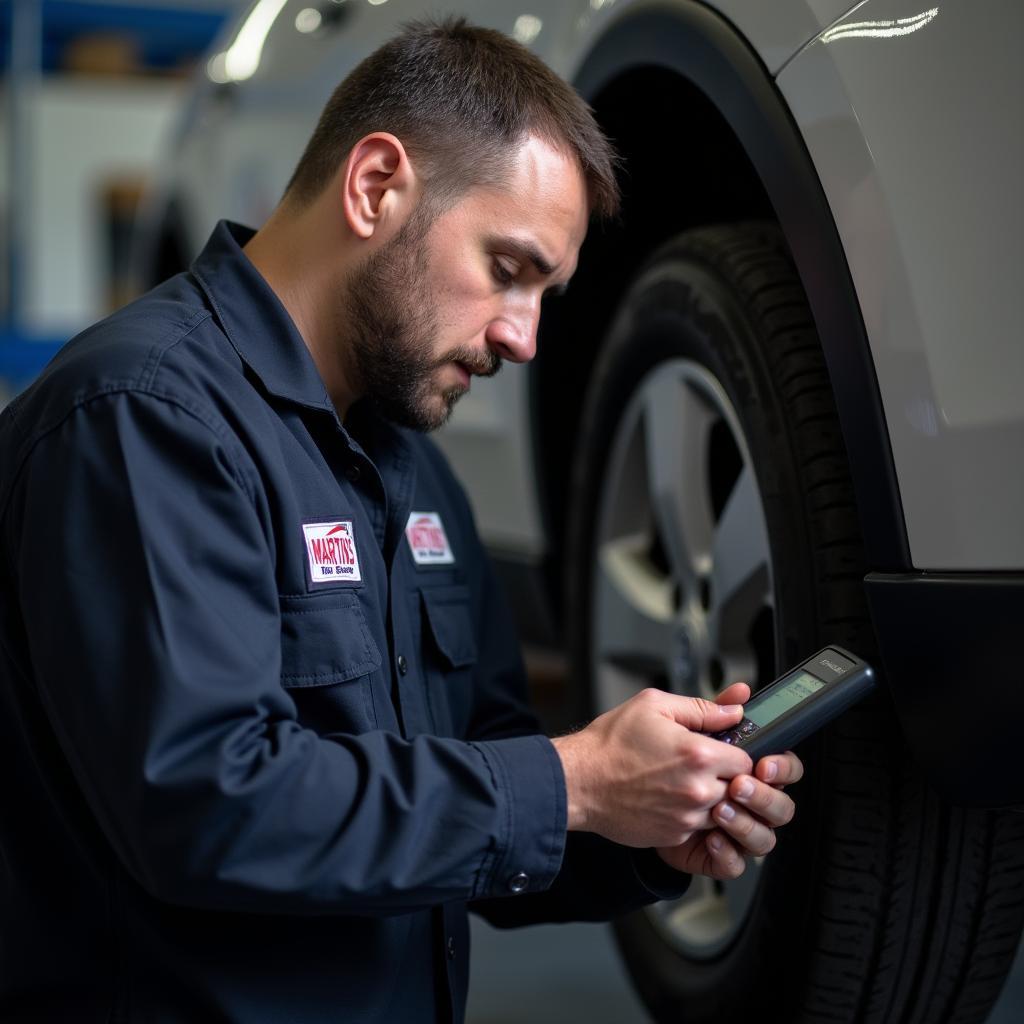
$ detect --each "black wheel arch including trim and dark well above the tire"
[530,3,910,630]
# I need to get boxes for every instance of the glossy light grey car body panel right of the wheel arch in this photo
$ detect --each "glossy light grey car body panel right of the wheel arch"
[778,0,1024,570]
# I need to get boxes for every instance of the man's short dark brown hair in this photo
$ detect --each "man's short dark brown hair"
[286,18,618,217]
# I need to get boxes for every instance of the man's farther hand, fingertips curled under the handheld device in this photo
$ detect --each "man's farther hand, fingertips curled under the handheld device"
[657,683,804,879]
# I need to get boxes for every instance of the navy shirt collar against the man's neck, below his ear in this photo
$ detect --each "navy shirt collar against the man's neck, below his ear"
[191,220,334,413]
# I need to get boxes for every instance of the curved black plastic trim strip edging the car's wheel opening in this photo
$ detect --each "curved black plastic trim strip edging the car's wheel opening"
[573,3,911,571]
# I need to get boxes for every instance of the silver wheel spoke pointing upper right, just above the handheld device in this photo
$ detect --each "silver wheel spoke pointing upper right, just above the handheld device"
[711,466,771,649]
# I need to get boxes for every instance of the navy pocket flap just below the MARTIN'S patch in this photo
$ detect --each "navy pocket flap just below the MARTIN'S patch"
[281,593,381,686]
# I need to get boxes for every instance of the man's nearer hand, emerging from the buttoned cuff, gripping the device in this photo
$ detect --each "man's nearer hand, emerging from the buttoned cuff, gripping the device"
[552,689,753,847]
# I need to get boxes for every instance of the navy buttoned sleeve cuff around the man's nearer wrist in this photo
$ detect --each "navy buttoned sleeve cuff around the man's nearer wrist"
[471,735,567,899]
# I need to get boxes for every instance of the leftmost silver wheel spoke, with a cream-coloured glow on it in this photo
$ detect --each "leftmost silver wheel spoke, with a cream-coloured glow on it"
[594,536,673,677]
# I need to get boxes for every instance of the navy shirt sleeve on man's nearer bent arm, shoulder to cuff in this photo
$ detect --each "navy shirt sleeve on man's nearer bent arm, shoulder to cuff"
[4,391,564,914]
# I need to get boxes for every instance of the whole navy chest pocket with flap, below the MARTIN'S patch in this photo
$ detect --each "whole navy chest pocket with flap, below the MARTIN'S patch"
[281,592,381,733]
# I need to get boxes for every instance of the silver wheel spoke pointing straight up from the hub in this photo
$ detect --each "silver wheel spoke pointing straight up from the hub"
[644,370,716,592]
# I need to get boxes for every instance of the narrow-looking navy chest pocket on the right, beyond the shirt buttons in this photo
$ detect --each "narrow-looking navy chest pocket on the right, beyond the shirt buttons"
[420,586,477,736]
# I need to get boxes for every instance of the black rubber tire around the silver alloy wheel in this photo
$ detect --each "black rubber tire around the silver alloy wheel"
[568,224,1024,1024]
